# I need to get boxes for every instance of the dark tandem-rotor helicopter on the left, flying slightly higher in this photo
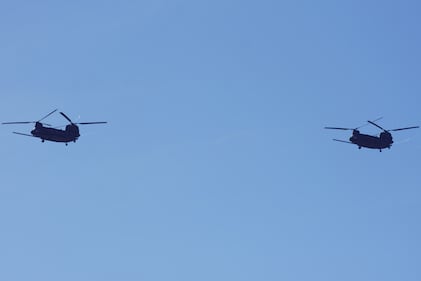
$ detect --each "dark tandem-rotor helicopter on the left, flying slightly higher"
[2,109,107,145]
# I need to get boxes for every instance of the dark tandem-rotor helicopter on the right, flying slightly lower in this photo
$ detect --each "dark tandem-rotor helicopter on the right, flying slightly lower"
[325,119,419,152]
